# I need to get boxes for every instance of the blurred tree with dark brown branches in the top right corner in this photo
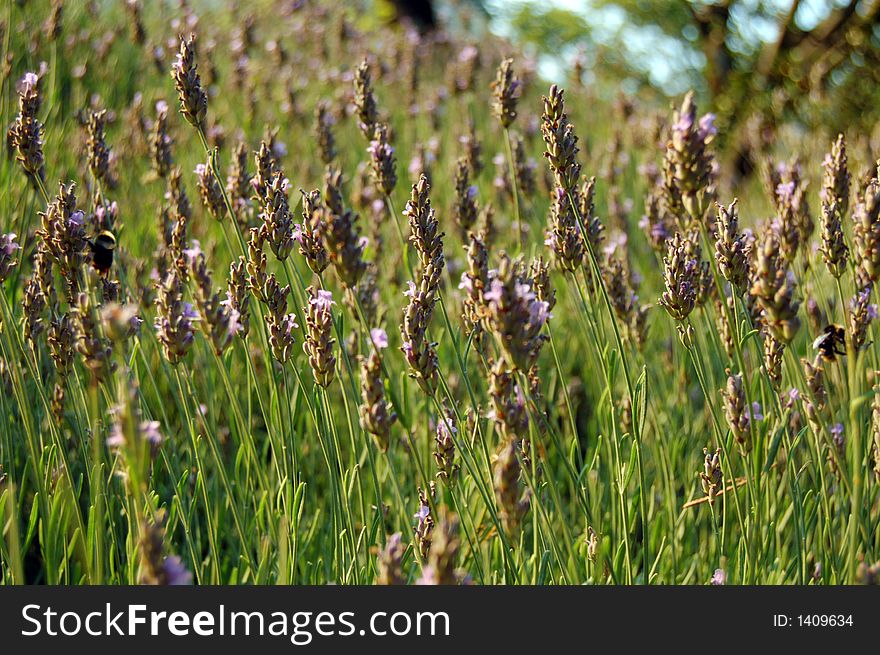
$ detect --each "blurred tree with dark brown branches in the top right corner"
[596,0,880,173]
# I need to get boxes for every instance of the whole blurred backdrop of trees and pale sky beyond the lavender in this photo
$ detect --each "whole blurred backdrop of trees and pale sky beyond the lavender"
[488,0,880,172]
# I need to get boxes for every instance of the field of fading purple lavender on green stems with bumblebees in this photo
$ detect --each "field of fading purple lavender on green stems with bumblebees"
[0,0,880,585]
